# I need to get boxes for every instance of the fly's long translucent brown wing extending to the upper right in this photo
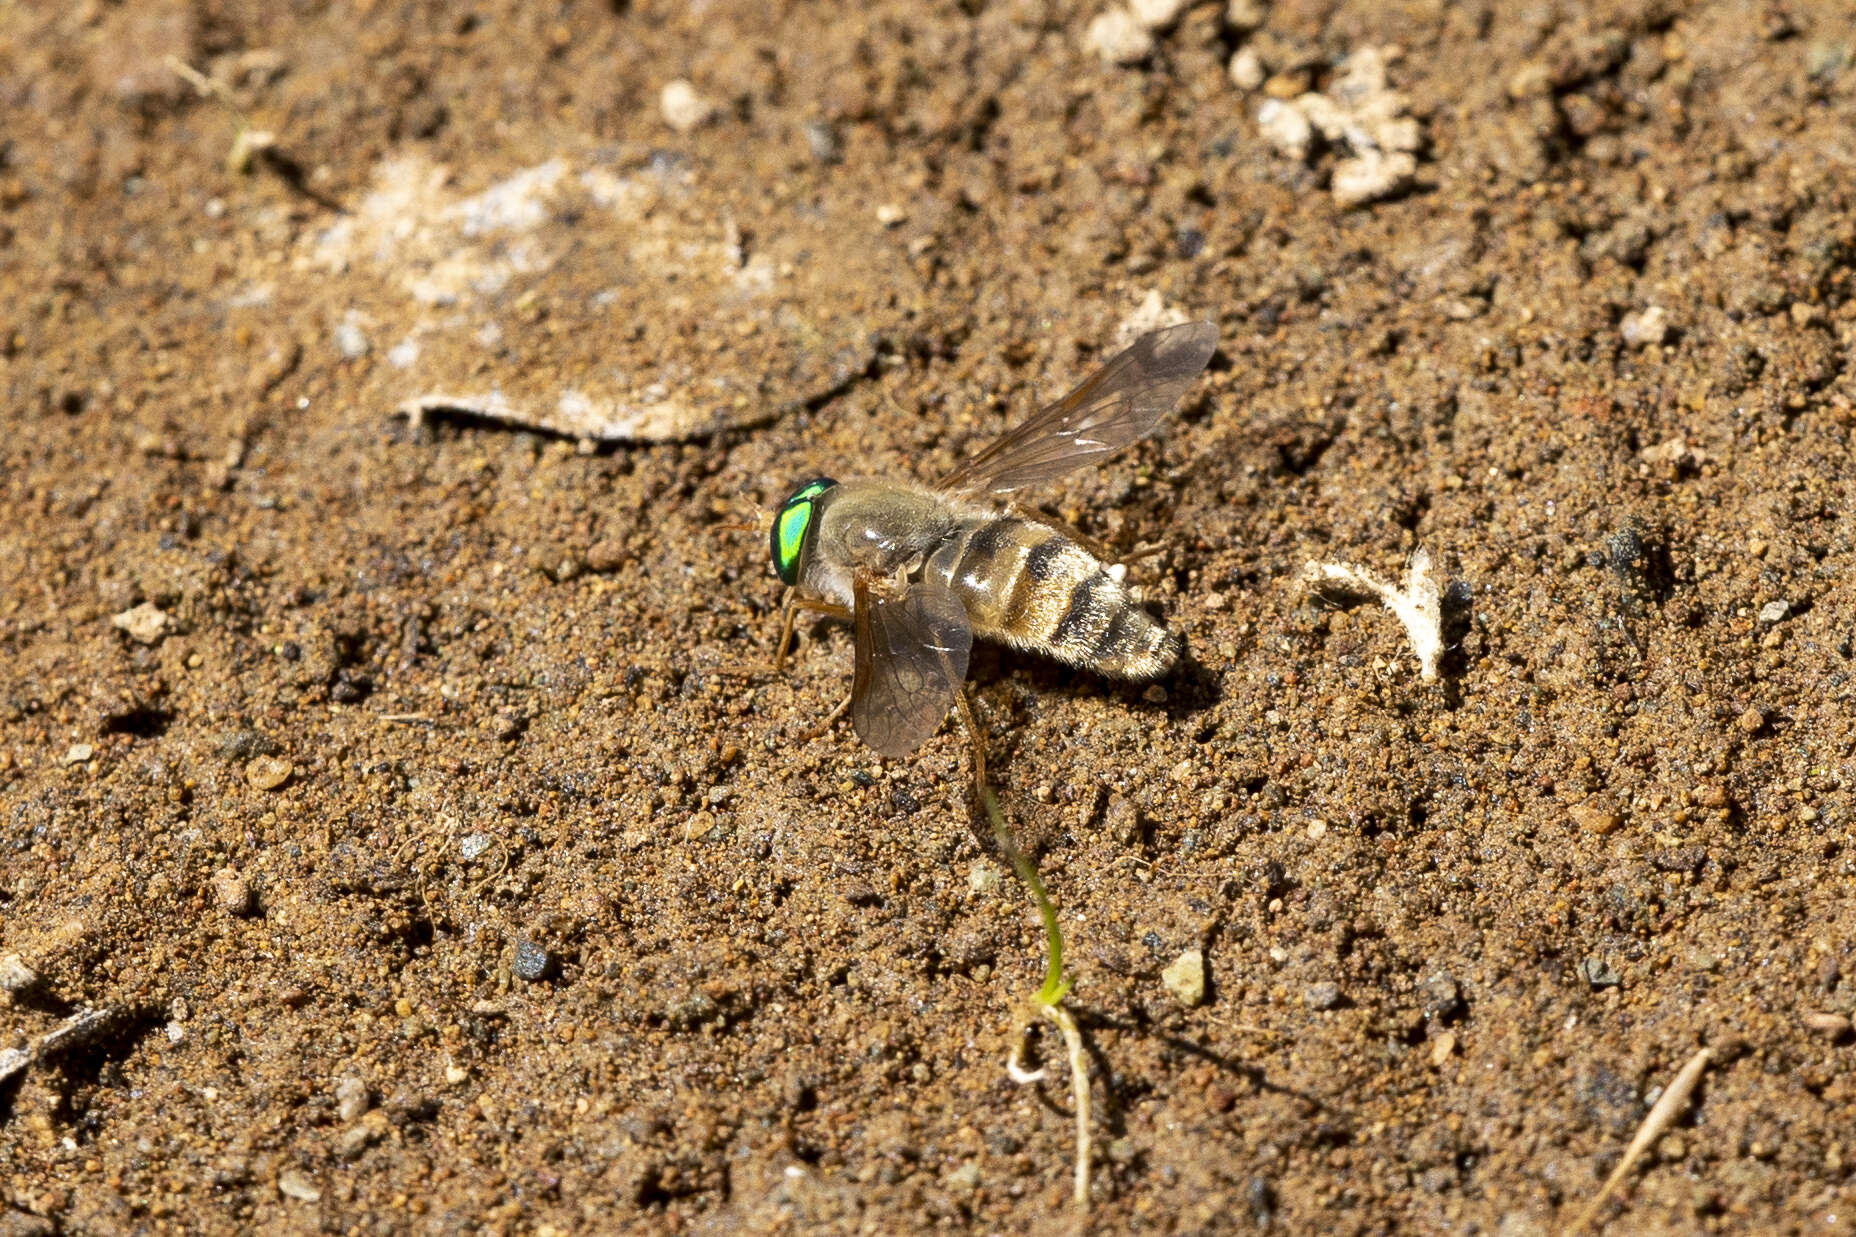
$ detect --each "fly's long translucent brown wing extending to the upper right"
[941,321,1218,494]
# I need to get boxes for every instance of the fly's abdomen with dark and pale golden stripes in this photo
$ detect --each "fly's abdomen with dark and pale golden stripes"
[922,516,1179,680]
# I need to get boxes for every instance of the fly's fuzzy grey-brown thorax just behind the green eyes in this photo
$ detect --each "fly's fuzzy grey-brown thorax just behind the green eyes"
[800,479,961,605]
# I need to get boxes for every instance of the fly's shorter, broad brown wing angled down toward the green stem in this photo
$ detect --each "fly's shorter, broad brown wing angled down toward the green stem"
[850,583,973,756]
